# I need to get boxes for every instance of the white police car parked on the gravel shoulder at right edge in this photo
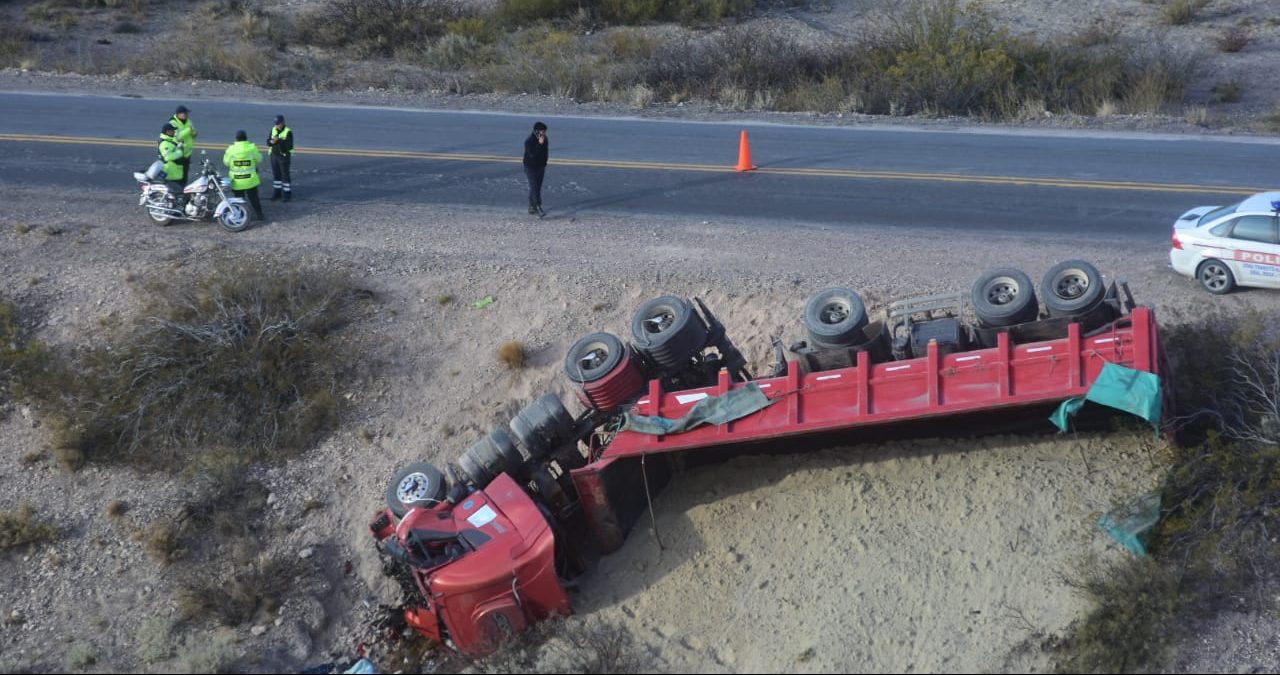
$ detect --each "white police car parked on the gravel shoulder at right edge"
[1169,192,1280,295]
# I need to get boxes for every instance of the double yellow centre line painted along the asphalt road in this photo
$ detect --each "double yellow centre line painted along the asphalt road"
[0,133,1268,195]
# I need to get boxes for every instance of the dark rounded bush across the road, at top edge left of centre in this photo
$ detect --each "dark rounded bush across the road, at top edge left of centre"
[298,0,463,56]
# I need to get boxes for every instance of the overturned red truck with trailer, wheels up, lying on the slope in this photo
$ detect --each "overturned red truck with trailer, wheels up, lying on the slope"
[370,260,1167,657]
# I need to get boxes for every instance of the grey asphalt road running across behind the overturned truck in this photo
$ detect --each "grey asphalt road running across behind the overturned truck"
[0,92,1280,240]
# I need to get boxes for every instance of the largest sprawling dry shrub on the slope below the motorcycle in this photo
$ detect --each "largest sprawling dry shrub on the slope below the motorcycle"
[26,260,357,471]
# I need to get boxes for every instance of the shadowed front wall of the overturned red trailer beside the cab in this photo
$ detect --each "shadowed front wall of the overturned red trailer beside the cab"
[571,455,672,553]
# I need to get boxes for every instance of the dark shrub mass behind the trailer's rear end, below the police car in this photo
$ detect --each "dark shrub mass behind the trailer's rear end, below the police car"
[1059,309,1280,672]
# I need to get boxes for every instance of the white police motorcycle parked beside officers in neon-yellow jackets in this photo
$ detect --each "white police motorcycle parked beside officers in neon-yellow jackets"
[133,159,248,232]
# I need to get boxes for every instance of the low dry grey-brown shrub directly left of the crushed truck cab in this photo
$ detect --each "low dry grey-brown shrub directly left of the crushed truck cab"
[175,555,297,626]
